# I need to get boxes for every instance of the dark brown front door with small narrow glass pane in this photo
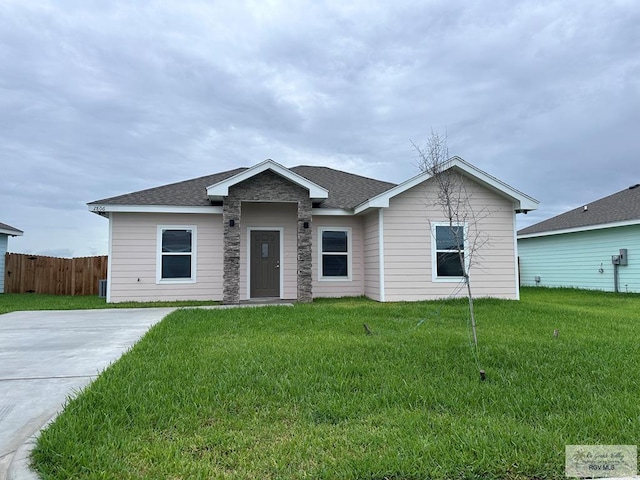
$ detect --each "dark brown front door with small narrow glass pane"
[250,230,280,298]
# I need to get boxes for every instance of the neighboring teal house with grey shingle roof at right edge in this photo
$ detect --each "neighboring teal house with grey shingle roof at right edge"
[518,184,640,292]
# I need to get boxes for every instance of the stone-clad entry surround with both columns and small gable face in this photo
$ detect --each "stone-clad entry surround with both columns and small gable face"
[222,170,313,304]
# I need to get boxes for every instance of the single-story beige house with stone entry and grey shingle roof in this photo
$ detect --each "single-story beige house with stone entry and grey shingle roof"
[88,157,538,304]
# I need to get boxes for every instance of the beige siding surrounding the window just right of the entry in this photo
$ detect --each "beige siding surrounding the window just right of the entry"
[311,215,364,297]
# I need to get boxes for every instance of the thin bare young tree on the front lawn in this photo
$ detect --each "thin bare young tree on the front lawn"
[411,131,488,379]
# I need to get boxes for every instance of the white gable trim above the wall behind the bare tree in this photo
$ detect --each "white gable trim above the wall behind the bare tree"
[355,156,539,213]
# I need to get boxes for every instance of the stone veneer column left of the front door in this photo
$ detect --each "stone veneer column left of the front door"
[222,198,241,304]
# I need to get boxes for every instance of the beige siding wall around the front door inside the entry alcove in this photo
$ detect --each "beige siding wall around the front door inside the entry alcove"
[240,202,298,300]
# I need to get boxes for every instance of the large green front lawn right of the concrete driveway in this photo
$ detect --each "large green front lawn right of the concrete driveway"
[32,289,640,479]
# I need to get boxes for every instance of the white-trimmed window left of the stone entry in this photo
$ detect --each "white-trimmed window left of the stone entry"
[156,225,197,283]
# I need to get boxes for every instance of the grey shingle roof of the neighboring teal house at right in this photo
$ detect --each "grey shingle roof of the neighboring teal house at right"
[518,185,640,235]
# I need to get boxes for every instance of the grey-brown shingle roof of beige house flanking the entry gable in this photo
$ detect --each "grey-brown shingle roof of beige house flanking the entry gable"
[89,165,395,209]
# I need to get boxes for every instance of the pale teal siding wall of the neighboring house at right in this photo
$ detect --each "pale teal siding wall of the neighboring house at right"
[518,225,640,292]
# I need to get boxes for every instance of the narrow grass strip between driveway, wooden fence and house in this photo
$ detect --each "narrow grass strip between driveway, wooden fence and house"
[0,293,219,314]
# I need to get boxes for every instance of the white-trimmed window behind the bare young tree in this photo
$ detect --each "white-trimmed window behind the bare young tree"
[431,223,468,281]
